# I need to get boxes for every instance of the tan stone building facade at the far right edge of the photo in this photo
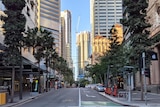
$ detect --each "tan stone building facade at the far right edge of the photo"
[147,0,160,93]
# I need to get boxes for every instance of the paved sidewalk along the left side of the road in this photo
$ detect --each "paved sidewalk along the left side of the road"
[0,89,54,107]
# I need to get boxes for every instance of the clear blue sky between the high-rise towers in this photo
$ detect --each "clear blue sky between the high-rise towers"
[61,0,90,79]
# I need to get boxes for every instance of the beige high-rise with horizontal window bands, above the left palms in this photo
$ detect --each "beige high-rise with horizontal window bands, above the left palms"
[40,0,61,55]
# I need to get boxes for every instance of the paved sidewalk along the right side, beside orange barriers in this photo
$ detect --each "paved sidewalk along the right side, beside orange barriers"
[100,91,160,107]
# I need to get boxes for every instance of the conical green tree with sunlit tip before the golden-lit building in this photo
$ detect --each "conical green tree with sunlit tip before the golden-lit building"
[100,26,124,86]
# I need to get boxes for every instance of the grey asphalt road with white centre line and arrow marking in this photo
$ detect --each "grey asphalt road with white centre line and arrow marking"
[12,88,125,107]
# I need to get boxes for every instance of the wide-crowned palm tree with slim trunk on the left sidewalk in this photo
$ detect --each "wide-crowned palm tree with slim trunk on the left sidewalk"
[23,27,55,92]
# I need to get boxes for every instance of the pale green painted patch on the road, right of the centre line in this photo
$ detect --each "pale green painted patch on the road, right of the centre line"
[81,101,120,106]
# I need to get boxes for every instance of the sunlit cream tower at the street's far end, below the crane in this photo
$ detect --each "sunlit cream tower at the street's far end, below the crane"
[76,31,91,74]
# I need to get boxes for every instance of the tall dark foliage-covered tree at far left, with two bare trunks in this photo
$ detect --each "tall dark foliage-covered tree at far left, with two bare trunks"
[1,0,26,102]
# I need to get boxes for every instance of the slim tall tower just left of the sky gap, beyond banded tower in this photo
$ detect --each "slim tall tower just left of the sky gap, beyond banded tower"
[61,10,72,68]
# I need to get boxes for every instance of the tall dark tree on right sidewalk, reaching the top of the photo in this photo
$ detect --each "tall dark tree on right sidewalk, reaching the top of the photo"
[121,0,152,100]
